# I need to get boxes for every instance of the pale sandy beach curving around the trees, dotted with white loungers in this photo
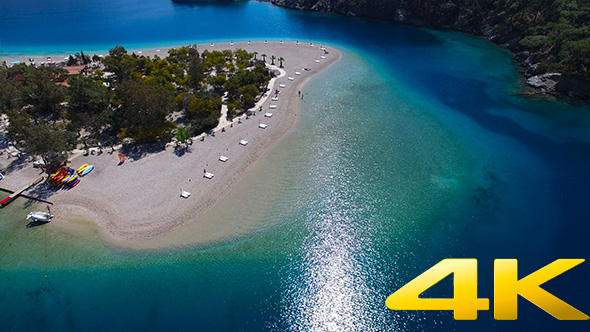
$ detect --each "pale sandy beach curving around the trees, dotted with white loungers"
[0,41,340,248]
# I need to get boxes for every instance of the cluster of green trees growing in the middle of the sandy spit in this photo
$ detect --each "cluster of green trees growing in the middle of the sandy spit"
[0,46,272,170]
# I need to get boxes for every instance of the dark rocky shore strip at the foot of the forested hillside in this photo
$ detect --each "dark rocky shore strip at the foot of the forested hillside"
[270,0,590,103]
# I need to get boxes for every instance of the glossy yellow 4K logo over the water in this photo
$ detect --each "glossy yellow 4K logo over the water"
[385,258,588,320]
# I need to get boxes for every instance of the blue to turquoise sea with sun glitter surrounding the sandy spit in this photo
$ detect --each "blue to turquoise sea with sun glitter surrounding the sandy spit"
[0,0,590,331]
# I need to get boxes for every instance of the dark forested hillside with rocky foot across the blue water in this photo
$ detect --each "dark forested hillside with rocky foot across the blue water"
[271,0,590,101]
